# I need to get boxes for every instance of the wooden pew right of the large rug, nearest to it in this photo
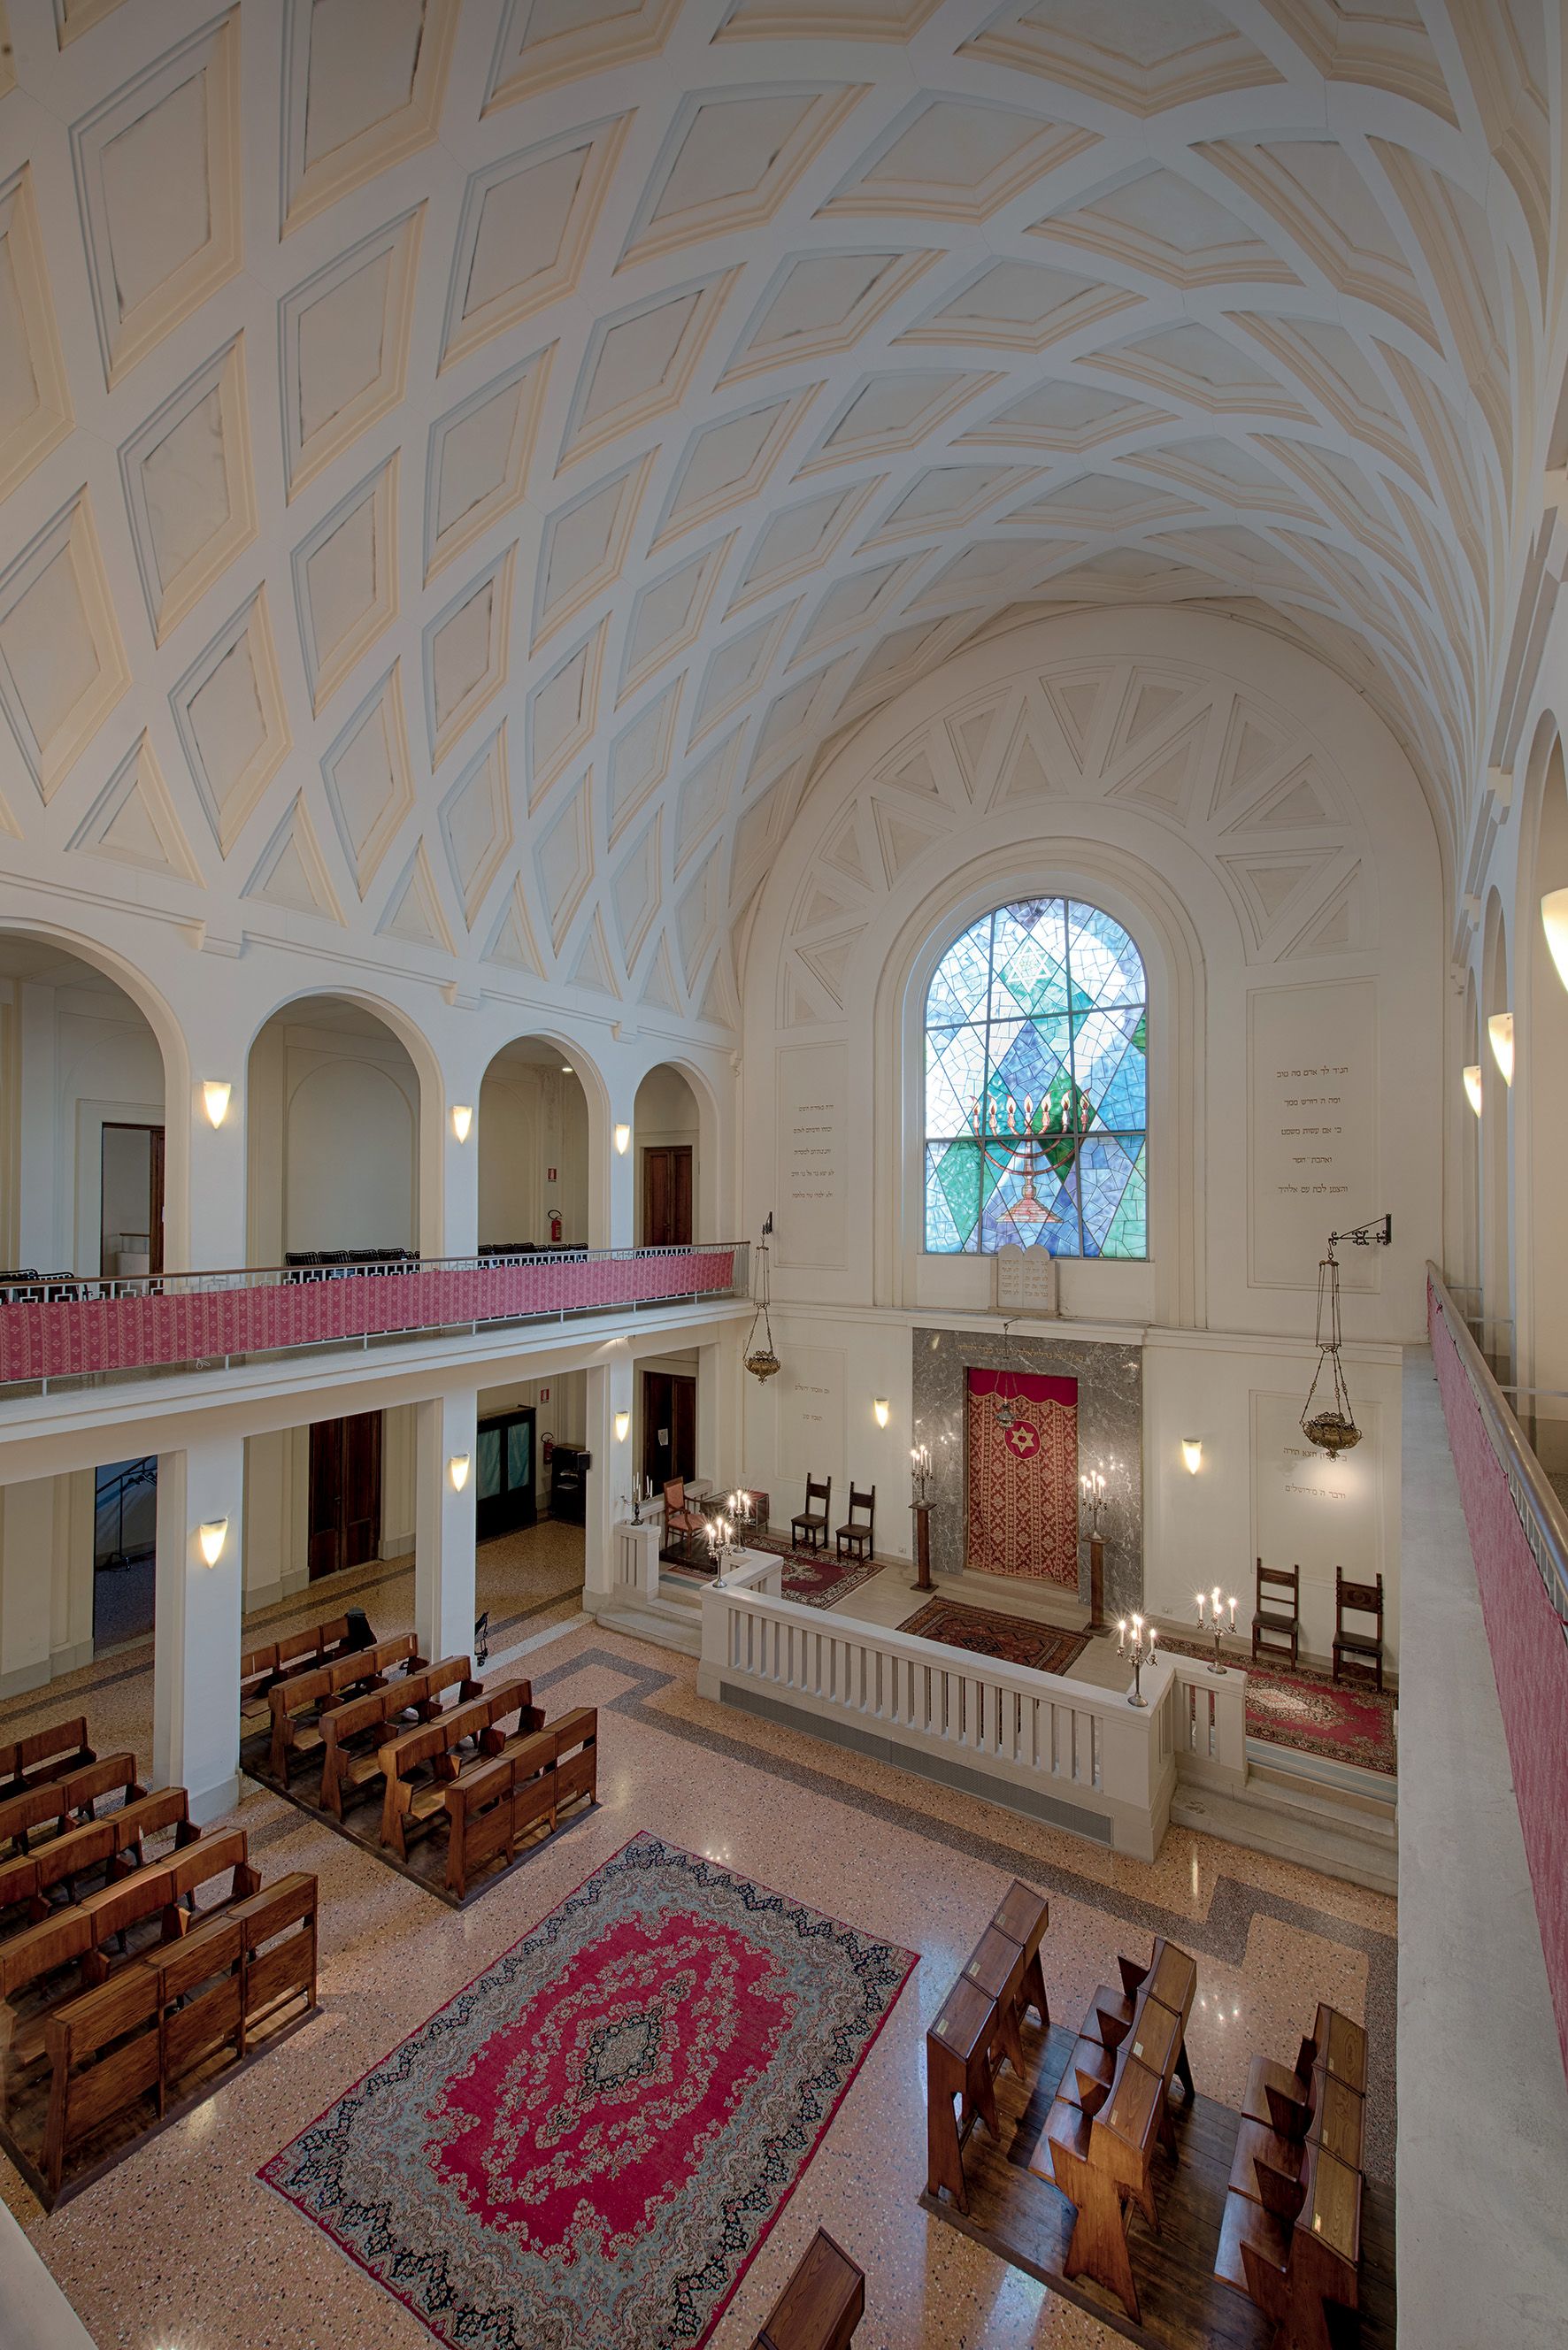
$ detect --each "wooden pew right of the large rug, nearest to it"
[926,1878,1051,2211]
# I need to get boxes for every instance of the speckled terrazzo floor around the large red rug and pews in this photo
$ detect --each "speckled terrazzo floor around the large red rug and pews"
[0,1578,1394,2350]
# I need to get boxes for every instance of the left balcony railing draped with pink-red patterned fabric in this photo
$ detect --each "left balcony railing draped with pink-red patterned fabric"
[0,1240,749,1396]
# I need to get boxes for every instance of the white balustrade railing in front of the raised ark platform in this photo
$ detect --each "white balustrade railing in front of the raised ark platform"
[698,1586,1203,1862]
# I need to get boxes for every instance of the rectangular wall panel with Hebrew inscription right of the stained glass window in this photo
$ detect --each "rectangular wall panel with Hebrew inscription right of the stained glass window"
[1249,980,1382,1290]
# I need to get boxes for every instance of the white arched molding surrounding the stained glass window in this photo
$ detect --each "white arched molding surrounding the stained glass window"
[874,837,1206,1328]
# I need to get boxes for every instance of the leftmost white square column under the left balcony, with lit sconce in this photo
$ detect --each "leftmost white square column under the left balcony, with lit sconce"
[153,1436,244,1821]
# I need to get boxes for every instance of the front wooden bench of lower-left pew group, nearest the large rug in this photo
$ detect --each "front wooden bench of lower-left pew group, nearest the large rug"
[42,1875,318,2195]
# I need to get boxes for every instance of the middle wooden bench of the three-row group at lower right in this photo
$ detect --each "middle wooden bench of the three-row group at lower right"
[1030,1941,1196,2324]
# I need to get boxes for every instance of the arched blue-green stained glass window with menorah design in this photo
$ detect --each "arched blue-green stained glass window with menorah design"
[924,898,1149,1257]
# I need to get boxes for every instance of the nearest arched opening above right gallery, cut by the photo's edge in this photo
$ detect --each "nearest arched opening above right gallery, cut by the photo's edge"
[1518,741,1568,1493]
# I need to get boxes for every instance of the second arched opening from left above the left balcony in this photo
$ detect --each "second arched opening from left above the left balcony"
[244,994,421,1264]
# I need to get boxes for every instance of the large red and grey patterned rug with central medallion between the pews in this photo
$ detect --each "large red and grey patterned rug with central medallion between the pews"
[257,1835,914,2350]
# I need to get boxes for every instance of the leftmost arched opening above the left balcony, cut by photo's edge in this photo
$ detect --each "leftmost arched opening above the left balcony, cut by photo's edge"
[0,928,171,1276]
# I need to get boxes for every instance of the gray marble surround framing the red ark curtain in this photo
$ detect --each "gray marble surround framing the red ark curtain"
[914,1328,1142,1619]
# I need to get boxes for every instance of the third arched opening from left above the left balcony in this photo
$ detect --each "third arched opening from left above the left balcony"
[477,1036,602,1248]
